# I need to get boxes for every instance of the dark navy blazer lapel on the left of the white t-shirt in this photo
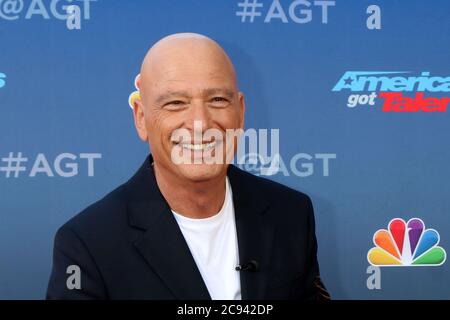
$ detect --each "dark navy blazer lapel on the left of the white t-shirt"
[128,156,211,299]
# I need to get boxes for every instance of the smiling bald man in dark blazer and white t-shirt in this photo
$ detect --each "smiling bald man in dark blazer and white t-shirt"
[47,33,329,300]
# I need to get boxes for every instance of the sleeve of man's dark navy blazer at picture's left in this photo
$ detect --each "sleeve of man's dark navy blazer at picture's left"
[46,226,107,300]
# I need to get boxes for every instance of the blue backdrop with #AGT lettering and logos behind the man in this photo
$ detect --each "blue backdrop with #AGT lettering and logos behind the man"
[0,0,450,299]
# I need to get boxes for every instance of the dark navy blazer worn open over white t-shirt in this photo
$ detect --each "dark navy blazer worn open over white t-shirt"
[47,156,327,299]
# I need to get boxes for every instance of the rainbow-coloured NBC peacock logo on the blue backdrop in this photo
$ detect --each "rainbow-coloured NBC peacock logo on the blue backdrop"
[367,218,447,267]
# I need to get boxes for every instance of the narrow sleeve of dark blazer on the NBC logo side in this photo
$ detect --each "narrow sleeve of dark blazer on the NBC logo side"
[306,197,331,300]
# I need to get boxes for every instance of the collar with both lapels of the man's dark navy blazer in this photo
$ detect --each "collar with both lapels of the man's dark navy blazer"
[127,155,273,300]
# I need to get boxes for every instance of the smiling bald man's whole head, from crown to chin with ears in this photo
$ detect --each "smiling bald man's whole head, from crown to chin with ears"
[133,33,245,181]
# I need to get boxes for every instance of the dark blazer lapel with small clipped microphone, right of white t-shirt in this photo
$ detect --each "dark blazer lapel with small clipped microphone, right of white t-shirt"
[228,166,274,300]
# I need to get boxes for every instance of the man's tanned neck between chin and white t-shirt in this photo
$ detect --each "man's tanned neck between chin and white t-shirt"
[154,164,226,219]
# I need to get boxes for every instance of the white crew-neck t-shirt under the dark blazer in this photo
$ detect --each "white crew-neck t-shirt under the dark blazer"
[172,177,241,300]
